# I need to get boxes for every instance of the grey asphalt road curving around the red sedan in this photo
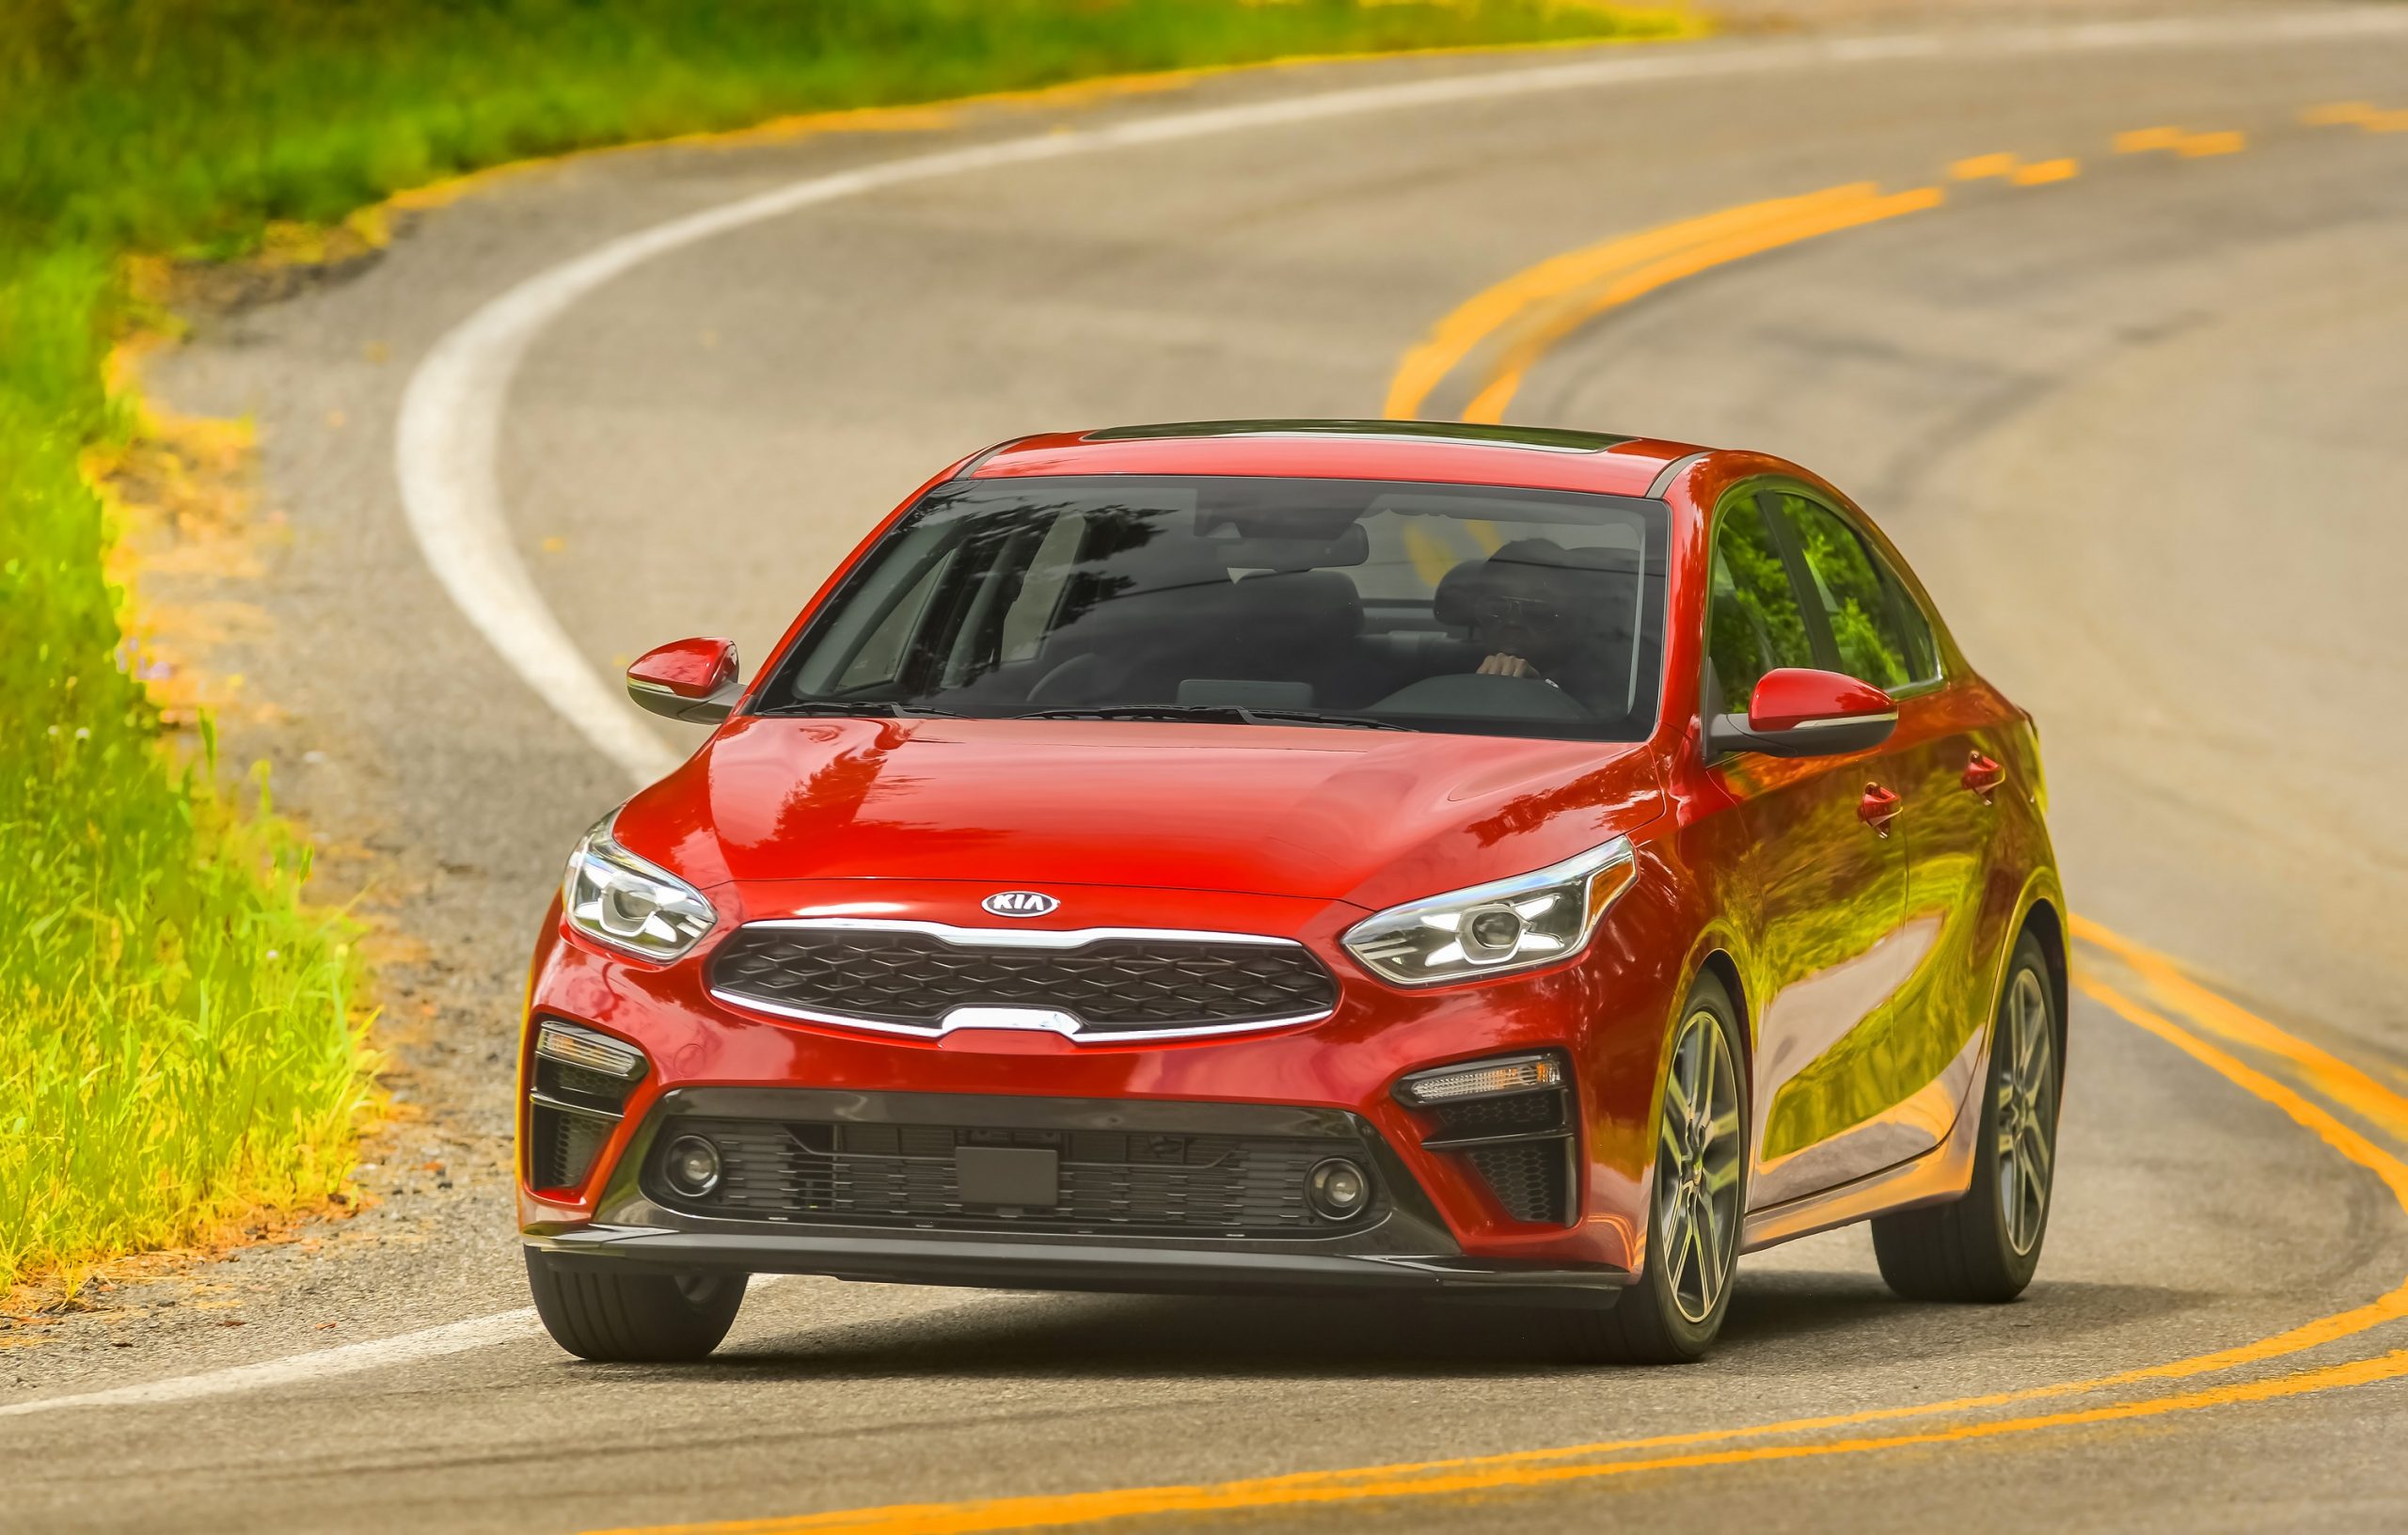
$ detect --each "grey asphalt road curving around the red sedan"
[0,8,2408,1530]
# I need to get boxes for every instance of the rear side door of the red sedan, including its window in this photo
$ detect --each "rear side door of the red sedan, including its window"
[1767,486,2013,1163]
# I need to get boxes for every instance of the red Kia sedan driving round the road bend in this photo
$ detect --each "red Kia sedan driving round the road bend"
[517,421,2066,1362]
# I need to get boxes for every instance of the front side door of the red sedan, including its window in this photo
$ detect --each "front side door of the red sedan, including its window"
[1703,486,1908,1208]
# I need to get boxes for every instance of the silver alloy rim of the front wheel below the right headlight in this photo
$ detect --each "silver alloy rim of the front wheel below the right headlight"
[1656,1008,1741,1323]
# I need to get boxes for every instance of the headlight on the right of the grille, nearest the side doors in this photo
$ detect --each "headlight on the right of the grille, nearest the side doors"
[1343,837,1638,987]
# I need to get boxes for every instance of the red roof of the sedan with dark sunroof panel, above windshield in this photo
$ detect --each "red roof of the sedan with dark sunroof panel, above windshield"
[963,421,1698,496]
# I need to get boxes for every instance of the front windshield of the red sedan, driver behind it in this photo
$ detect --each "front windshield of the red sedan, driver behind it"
[756,476,1669,741]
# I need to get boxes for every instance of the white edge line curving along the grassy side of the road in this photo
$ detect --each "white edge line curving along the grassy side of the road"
[0,8,2369,1417]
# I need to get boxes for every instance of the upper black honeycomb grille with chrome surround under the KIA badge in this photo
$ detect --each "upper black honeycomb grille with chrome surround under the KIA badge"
[710,924,1339,1035]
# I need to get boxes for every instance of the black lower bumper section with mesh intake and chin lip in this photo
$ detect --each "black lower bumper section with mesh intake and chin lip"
[525,1087,1630,1302]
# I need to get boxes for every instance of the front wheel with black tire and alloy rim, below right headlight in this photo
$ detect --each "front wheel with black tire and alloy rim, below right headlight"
[1541,974,1749,1364]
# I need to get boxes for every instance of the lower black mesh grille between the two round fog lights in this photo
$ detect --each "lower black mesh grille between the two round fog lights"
[645,1116,1387,1237]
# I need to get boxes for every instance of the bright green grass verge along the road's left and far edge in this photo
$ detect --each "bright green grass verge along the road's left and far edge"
[0,0,1683,1290]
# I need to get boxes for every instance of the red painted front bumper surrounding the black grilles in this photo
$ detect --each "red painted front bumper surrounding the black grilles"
[517,880,1681,1290]
